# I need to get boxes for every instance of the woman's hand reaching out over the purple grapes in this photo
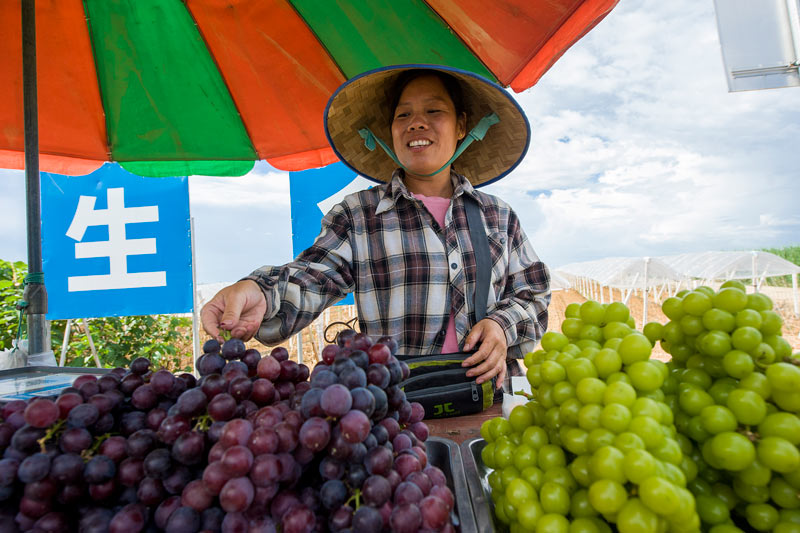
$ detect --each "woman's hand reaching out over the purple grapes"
[200,280,267,341]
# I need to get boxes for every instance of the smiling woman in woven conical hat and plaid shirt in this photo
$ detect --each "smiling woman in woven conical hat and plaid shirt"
[202,65,550,387]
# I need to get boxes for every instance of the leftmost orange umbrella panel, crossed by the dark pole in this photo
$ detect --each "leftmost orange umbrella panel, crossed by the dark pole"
[0,0,111,174]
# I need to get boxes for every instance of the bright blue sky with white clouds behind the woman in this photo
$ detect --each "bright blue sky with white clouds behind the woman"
[0,0,800,283]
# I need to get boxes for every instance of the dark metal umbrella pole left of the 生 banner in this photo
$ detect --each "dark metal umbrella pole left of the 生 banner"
[21,0,50,366]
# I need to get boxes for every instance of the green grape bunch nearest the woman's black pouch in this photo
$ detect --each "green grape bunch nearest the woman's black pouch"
[481,301,701,533]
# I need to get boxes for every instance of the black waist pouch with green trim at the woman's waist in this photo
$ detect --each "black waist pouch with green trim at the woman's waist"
[400,353,495,419]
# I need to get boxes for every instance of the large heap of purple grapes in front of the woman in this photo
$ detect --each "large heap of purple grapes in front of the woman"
[0,330,458,533]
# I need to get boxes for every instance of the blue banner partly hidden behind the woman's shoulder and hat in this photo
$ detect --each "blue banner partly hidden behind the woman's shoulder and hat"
[289,163,375,305]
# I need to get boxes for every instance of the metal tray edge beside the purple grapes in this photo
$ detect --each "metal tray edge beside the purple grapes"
[425,437,483,533]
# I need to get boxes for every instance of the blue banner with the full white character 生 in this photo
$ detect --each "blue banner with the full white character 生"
[41,164,192,320]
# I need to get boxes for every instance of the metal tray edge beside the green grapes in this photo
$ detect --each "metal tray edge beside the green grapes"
[461,438,508,533]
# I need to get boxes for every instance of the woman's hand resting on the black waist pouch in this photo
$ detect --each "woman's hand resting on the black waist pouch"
[461,318,508,389]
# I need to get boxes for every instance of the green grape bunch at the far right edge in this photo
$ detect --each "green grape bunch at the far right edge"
[644,281,800,533]
